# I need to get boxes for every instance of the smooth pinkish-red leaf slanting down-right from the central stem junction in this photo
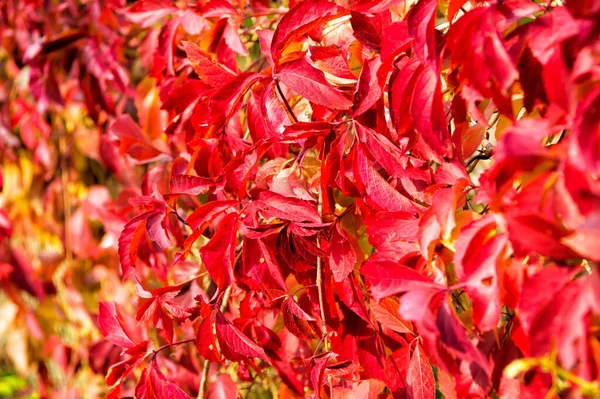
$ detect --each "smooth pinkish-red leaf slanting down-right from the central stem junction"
[354,146,416,212]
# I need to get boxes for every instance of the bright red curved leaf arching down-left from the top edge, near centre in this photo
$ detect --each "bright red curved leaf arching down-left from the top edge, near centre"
[271,0,346,63]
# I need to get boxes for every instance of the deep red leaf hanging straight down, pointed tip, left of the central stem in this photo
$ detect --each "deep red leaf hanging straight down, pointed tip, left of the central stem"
[200,212,239,290]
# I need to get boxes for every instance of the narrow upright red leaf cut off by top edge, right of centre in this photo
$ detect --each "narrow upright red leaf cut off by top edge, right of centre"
[407,0,438,70]
